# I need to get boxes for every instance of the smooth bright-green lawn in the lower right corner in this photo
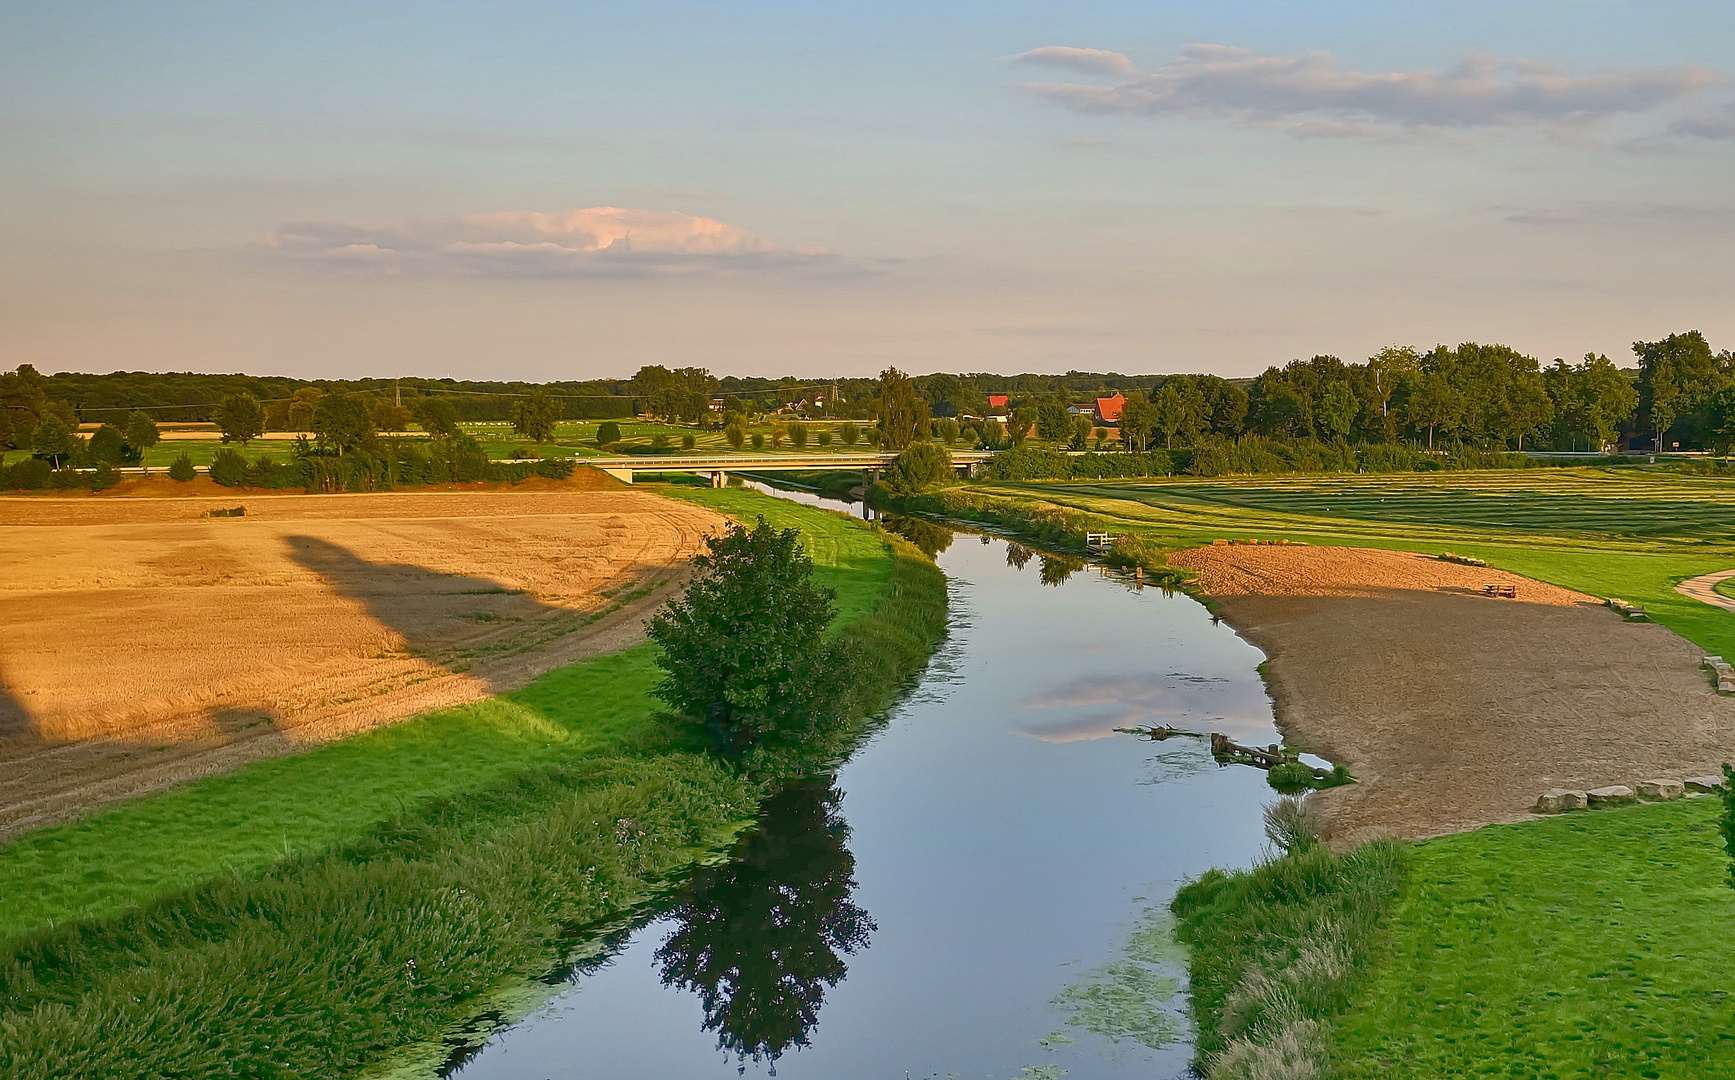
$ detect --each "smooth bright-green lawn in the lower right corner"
[1336,799,1735,1080]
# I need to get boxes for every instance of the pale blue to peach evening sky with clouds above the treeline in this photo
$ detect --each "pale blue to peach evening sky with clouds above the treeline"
[0,0,1735,379]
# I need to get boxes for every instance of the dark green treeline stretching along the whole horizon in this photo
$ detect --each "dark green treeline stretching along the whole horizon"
[0,330,1735,464]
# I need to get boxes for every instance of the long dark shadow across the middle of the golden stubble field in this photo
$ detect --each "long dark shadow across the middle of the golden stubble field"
[283,537,573,667]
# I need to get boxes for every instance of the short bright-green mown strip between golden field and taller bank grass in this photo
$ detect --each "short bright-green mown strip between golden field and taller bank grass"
[0,488,892,938]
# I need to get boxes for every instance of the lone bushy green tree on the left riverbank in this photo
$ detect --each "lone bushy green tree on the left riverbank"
[649,517,836,754]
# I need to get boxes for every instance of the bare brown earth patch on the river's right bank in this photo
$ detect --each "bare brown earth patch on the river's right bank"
[1169,545,1735,842]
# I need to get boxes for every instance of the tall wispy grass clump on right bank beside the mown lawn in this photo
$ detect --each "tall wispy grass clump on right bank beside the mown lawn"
[1171,833,1409,1080]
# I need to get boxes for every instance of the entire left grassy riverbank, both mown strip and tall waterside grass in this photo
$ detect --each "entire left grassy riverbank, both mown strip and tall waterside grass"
[0,490,946,1078]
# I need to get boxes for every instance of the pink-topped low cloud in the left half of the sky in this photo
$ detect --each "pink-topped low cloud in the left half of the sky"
[262,207,824,276]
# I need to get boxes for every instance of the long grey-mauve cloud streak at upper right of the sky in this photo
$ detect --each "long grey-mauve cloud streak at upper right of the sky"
[1018,45,1719,137]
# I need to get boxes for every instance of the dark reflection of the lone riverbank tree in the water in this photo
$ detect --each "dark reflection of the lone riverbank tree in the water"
[656,781,878,1073]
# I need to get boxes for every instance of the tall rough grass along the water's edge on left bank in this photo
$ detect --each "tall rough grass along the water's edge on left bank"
[0,517,946,1080]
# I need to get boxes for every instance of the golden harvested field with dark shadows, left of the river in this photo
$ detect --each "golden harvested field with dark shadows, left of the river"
[0,481,722,833]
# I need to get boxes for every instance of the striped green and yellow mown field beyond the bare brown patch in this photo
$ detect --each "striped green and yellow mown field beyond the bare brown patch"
[982,467,1735,655]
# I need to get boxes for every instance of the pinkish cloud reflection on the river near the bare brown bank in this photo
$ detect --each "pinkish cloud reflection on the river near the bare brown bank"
[1018,672,1272,743]
